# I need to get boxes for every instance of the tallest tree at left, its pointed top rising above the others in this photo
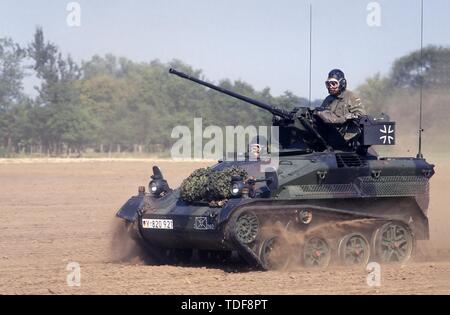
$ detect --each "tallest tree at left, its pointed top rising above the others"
[28,28,90,154]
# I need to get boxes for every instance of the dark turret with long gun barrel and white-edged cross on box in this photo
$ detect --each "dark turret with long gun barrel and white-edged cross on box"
[169,68,395,154]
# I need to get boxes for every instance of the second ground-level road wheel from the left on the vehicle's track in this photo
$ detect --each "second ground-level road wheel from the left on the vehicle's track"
[303,236,331,268]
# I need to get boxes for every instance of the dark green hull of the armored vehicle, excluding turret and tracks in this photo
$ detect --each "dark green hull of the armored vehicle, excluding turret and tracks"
[117,153,433,250]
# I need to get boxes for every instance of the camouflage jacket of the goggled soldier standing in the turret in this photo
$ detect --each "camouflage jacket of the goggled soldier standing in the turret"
[317,90,366,124]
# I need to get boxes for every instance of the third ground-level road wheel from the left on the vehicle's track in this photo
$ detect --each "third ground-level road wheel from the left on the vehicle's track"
[338,233,370,266]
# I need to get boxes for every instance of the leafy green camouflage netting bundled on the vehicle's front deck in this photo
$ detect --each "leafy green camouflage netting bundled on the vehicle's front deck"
[180,166,248,202]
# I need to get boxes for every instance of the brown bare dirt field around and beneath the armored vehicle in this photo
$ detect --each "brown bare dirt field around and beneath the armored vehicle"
[0,160,450,294]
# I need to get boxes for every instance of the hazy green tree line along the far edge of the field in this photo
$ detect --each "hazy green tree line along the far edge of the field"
[0,28,450,156]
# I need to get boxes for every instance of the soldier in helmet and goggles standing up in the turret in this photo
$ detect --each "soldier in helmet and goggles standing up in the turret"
[317,69,366,124]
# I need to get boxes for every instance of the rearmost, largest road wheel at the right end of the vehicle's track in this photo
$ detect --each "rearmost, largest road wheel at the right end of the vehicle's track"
[372,221,415,263]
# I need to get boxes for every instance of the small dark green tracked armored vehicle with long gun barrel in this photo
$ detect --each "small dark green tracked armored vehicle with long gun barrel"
[117,69,434,269]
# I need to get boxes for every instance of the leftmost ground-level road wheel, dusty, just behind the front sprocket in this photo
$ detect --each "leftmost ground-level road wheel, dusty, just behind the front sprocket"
[259,236,289,270]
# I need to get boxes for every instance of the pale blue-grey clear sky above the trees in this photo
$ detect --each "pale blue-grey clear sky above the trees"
[0,0,450,99]
